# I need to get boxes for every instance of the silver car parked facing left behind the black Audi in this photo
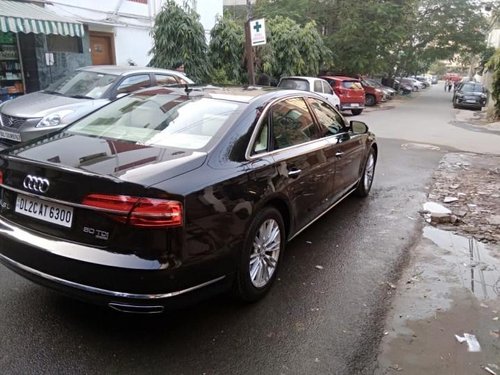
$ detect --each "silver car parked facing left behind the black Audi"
[0,65,193,144]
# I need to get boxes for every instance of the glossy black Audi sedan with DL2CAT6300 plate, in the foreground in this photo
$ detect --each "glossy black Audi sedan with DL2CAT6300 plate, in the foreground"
[0,87,378,313]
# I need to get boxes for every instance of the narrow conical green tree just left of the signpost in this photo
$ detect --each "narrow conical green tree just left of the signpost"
[209,17,245,84]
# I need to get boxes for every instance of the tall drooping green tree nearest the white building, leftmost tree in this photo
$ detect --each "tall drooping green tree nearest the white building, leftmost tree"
[149,0,210,82]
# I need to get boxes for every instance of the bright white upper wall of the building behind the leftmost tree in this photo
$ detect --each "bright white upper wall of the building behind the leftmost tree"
[46,0,223,66]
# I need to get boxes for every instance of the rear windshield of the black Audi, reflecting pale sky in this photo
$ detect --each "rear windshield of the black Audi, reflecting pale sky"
[66,93,242,150]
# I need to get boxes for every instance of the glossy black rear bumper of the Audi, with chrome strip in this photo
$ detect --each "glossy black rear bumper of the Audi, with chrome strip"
[0,218,231,312]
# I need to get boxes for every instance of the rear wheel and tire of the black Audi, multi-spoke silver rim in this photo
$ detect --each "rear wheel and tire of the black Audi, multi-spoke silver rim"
[233,207,285,302]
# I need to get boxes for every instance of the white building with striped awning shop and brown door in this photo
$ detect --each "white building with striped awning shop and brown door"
[0,0,223,96]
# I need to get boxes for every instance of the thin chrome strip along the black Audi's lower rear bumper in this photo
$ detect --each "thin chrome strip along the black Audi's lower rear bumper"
[0,254,226,300]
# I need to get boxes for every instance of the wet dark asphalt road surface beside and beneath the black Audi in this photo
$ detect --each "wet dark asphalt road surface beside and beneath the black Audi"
[0,86,453,375]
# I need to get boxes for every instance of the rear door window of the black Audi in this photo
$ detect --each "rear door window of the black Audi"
[270,98,320,150]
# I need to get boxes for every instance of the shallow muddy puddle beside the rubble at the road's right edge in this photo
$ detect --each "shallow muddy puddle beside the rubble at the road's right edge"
[424,226,500,299]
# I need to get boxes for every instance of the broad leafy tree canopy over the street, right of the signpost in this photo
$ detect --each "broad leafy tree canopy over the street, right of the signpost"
[246,0,487,75]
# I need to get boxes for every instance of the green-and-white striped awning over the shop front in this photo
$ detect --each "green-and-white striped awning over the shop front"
[0,0,84,37]
